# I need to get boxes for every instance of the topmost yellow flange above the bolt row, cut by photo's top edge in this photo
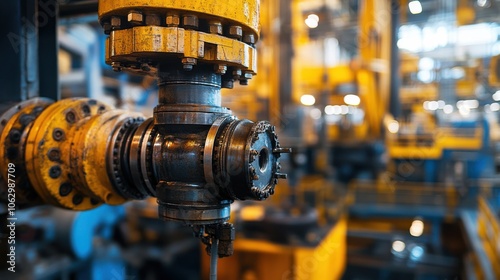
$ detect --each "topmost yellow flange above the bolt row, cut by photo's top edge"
[98,0,260,38]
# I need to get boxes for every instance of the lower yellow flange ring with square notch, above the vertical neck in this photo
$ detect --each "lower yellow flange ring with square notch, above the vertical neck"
[106,26,257,74]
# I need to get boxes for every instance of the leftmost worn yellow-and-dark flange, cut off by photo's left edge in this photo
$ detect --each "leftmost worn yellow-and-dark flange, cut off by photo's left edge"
[0,98,52,205]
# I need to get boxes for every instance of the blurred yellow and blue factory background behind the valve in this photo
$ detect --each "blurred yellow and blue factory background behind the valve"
[0,0,500,280]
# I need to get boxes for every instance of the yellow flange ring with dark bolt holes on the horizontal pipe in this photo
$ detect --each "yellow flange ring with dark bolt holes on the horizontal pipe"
[25,99,109,210]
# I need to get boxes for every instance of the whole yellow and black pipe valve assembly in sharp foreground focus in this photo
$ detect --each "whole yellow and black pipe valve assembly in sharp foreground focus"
[0,0,289,278]
